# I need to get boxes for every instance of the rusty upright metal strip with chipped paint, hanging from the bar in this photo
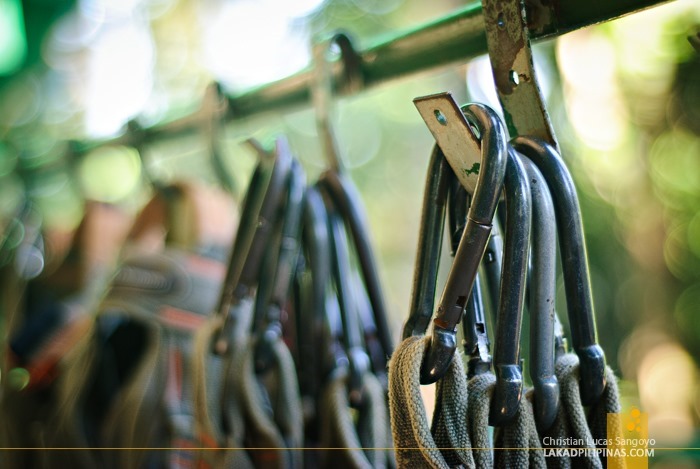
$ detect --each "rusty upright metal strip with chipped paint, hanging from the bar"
[482,0,559,150]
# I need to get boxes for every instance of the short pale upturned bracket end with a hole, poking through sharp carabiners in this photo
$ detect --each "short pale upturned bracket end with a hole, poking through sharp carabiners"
[413,92,481,194]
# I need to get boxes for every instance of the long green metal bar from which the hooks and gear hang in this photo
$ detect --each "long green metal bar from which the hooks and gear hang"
[78,0,670,151]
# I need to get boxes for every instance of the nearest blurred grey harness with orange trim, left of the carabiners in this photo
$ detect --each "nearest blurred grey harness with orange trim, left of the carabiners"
[33,180,238,467]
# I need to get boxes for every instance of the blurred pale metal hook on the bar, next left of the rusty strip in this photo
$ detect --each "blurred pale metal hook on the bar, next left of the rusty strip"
[311,32,364,171]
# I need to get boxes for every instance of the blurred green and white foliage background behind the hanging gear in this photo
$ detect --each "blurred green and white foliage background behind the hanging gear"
[0,0,700,467]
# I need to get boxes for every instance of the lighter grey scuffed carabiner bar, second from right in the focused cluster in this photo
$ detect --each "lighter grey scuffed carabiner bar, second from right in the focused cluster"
[521,157,559,431]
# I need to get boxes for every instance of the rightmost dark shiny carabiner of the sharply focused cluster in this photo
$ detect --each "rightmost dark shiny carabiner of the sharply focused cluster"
[512,137,606,405]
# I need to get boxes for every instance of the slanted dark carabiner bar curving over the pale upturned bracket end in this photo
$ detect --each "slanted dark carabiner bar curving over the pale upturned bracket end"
[414,104,507,384]
